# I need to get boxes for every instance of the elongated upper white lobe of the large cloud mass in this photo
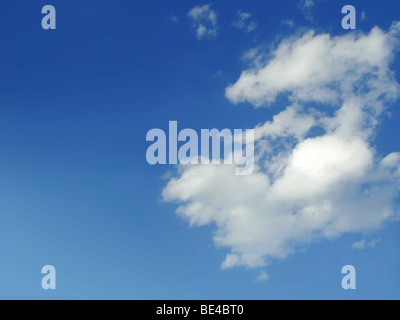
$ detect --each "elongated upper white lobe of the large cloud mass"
[226,27,398,106]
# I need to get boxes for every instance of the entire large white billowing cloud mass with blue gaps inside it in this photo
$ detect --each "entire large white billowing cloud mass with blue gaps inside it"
[162,23,400,269]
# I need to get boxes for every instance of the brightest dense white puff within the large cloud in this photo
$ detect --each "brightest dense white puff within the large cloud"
[271,133,372,201]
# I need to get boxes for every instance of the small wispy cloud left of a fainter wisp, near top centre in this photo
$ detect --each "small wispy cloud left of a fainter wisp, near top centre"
[188,4,217,40]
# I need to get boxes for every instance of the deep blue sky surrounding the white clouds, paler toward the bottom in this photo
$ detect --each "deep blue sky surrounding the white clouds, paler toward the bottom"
[0,0,400,299]
